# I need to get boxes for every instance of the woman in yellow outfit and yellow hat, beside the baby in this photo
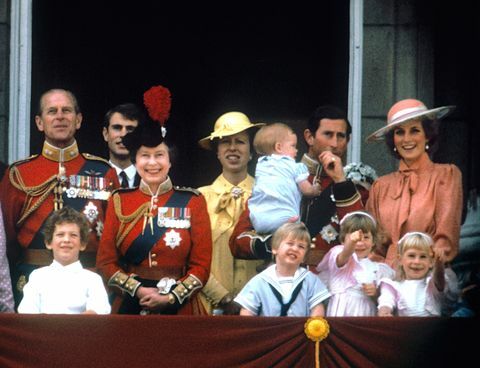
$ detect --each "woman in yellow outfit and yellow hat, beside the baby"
[198,111,264,314]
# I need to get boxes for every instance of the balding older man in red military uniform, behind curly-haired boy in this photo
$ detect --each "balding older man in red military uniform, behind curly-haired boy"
[0,89,119,305]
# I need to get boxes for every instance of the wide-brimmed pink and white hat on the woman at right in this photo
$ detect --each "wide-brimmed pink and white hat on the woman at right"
[367,98,455,142]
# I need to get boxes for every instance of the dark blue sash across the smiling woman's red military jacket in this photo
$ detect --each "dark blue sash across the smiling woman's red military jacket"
[124,191,193,265]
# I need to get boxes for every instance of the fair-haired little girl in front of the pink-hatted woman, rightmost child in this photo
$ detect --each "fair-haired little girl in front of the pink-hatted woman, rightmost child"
[378,231,458,317]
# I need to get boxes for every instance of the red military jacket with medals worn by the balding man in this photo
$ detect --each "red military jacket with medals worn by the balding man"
[0,142,119,262]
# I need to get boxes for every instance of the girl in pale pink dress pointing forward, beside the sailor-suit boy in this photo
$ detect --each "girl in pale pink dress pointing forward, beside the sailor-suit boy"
[317,211,394,317]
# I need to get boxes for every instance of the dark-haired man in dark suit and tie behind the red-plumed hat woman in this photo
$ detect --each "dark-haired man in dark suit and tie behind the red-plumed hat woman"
[103,103,143,188]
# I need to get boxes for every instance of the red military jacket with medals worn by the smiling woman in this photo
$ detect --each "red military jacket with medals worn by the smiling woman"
[97,179,212,312]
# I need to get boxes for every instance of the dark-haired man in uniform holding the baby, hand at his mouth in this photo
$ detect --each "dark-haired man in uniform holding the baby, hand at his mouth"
[229,106,373,269]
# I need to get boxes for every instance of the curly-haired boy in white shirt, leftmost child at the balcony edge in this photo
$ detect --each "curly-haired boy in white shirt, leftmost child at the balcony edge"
[18,207,111,314]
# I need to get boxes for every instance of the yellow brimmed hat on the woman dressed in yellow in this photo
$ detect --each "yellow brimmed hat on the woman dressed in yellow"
[198,111,265,149]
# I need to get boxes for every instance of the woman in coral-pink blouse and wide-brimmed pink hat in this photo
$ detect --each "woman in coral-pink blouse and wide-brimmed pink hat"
[367,99,463,266]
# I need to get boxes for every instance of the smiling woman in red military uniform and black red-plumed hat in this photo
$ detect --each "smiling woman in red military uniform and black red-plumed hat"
[97,86,212,314]
